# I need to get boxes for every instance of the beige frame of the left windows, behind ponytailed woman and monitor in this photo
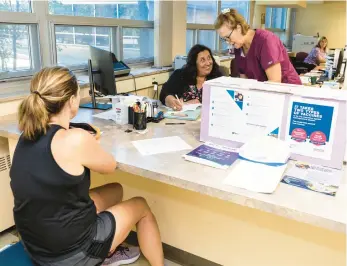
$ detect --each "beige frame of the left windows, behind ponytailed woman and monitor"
[0,0,154,81]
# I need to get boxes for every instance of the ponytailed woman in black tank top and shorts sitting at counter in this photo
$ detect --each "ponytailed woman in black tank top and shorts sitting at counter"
[10,67,164,266]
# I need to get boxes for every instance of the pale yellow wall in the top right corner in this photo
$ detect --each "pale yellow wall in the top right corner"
[294,1,346,48]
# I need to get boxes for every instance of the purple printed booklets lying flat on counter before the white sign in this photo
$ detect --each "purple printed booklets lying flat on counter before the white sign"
[183,143,238,169]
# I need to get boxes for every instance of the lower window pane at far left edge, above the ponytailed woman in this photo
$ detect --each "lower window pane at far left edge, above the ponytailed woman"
[0,23,40,79]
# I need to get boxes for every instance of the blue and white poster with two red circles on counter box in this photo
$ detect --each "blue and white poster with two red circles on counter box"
[286,96,338,160]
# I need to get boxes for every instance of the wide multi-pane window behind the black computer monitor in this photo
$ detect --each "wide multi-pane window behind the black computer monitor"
[48,0,154,69]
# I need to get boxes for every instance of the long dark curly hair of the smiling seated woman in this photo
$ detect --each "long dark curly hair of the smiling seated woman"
[183,44,222,85]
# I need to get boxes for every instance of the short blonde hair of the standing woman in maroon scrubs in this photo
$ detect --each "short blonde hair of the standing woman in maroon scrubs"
[214,8,250,35]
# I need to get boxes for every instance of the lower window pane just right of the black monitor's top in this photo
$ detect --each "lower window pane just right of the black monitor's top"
[123,28,154,62]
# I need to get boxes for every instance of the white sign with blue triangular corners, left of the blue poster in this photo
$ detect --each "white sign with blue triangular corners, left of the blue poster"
[208,87,285,143]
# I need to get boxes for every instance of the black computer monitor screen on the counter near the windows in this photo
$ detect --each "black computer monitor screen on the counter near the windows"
[89,46,117,95]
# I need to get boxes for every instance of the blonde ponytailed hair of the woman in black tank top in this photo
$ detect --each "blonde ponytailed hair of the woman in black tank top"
[18,67,79,140]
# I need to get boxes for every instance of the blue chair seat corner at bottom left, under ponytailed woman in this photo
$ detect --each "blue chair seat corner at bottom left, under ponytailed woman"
[0,242,34,266]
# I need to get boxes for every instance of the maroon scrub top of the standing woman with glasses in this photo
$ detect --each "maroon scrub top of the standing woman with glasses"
[235,29,301,85]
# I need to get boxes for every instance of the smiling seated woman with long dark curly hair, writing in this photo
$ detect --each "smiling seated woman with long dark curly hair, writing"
[160,44,222,111]
